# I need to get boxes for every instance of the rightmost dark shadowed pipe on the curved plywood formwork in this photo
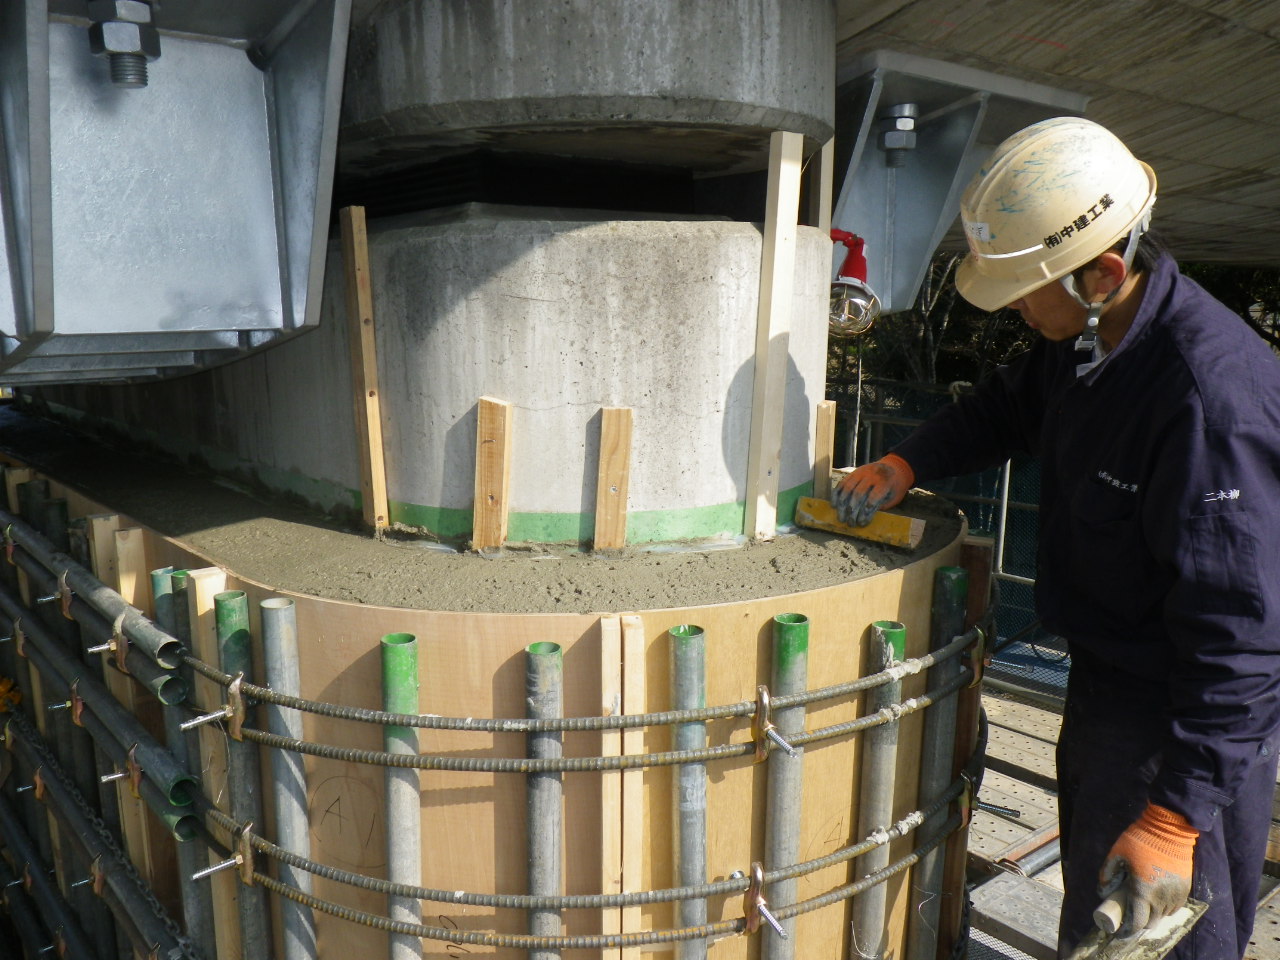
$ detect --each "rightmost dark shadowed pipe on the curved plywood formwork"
[906,567,969,960]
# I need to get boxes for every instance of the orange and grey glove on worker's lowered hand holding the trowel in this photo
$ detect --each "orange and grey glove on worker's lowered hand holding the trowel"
[1098,804,1199,937]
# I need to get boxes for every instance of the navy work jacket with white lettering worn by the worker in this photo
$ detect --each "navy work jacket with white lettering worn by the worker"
[895,257,1280,831]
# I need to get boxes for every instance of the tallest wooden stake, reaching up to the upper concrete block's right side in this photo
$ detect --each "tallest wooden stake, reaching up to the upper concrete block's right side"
[745,131,804,540]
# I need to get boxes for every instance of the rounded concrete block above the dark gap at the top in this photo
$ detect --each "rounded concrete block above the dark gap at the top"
[342,0,836,172]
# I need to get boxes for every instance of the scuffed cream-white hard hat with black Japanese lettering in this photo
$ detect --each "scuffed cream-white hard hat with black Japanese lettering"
[956,116,1156,310]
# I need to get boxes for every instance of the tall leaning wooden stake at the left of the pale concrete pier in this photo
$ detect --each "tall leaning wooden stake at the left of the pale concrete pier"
[340,206,388,532]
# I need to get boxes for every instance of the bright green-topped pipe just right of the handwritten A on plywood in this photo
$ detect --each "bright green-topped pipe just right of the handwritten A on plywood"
[381,634,422,960]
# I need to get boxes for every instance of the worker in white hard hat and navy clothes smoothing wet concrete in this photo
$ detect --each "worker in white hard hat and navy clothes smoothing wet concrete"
[832,118,1280,960]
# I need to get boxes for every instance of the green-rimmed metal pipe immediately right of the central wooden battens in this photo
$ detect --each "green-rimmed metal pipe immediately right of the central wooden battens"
[667,623,707,960]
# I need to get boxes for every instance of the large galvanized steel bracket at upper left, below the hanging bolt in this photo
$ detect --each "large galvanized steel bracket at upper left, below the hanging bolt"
[0,0,351,383]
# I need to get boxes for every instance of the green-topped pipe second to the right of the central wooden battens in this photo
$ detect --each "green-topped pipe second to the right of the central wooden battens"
[760,613,809,960]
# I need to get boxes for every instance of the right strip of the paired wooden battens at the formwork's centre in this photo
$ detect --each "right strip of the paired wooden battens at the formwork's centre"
[620,617,646,960]
